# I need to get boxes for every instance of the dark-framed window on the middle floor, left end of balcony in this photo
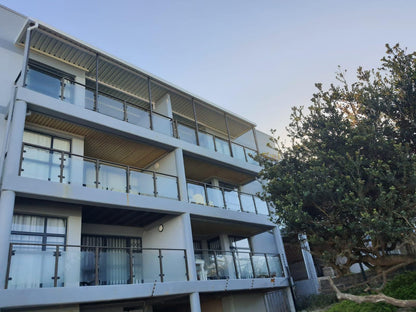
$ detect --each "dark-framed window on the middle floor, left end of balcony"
[20,130,71,183]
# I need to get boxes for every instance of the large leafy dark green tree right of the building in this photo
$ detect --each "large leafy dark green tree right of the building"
[259,45,416,274]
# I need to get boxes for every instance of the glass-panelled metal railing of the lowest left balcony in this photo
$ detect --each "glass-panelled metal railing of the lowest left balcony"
[5,243,189,289]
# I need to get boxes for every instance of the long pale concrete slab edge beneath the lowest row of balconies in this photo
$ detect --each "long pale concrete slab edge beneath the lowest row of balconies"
[0,277,289,308]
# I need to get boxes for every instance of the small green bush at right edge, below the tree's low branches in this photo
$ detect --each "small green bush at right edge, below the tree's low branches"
[383,272,416,299]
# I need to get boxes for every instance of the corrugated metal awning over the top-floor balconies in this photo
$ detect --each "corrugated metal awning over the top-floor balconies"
[16,21,256,139]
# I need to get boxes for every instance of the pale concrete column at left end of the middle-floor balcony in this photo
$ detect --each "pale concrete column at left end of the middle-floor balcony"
[2,101,27,180]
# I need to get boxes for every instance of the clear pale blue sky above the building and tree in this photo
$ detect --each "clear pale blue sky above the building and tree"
[0,0,416,138]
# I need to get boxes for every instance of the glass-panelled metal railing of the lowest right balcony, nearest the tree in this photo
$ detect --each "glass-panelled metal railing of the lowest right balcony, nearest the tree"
[195,249,284,280]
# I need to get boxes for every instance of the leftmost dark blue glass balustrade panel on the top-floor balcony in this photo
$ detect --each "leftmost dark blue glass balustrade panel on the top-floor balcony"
[26,69,61,99]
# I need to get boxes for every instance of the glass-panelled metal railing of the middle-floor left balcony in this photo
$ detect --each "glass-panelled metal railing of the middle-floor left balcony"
[19,143,180,200]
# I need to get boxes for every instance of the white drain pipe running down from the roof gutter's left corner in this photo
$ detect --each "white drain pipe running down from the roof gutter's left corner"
[0,22,39,185]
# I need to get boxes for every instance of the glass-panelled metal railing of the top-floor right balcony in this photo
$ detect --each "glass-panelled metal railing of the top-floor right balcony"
[175,122,259,165]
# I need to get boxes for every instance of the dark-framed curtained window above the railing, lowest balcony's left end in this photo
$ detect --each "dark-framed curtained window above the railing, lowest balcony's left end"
[11,214,66,250]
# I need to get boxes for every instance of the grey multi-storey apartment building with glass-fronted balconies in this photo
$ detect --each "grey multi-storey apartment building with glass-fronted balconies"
[0,7,300,312]
